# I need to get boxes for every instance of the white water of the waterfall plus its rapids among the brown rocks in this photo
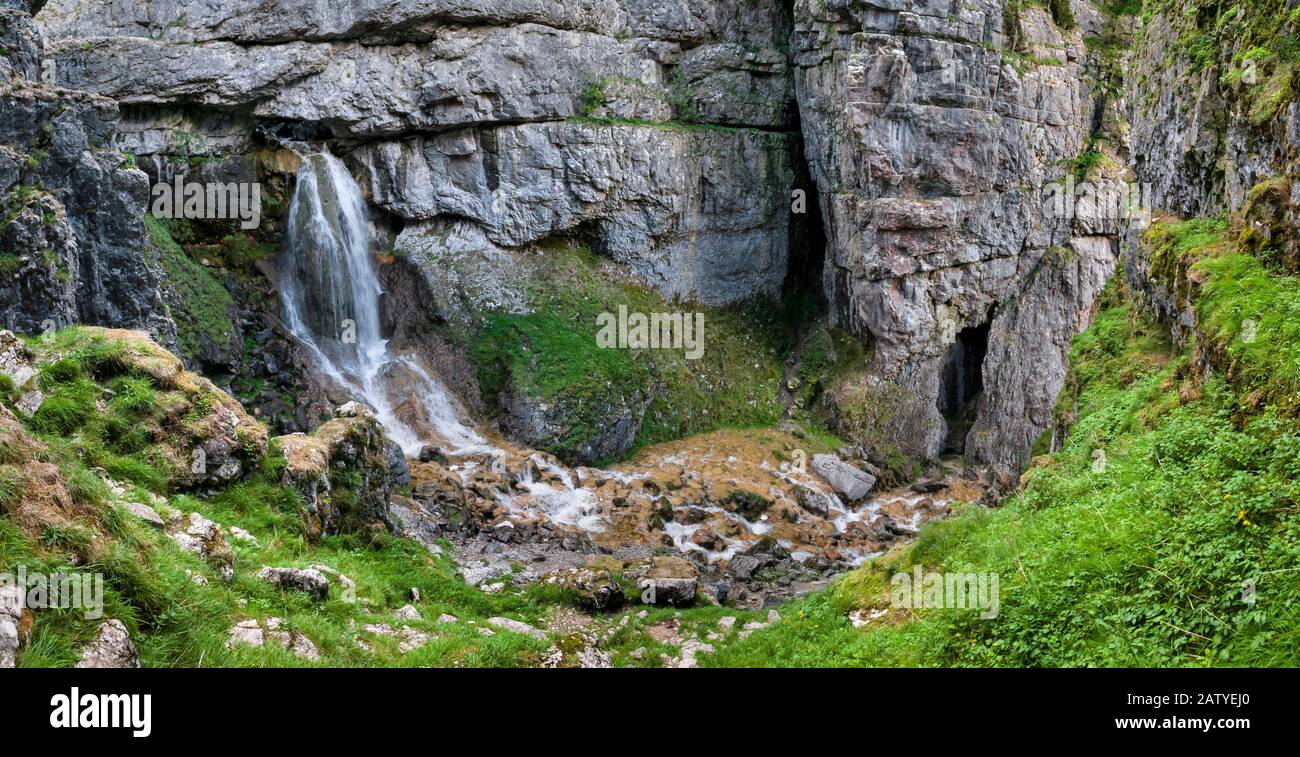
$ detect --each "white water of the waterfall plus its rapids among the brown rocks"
[281,152,904,562]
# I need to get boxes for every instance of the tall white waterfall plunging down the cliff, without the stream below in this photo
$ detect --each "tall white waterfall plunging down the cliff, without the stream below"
[281,152,488,455]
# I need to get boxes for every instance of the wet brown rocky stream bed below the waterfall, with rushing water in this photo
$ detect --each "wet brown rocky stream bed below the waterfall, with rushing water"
[394,432,982,609]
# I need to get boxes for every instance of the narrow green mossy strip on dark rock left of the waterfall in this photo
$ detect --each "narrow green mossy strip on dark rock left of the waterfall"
[144,216,239,364]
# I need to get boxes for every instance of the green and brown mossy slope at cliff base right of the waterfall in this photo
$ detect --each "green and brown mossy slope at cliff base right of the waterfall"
[472,247,811,458]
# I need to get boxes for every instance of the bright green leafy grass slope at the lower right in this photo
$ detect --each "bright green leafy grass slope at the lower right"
[705,293,1300,666]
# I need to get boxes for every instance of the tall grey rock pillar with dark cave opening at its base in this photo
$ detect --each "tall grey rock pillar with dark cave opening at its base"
[793,0,1114,467]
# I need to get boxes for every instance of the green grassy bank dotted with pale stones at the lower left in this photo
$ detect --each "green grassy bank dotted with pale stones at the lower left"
[0,329,598,667]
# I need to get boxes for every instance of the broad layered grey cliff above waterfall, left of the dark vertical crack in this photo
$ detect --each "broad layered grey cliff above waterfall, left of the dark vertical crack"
[40,0,797,304]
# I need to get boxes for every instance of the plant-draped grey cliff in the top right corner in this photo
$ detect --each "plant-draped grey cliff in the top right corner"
[1125,7,1300,273]
